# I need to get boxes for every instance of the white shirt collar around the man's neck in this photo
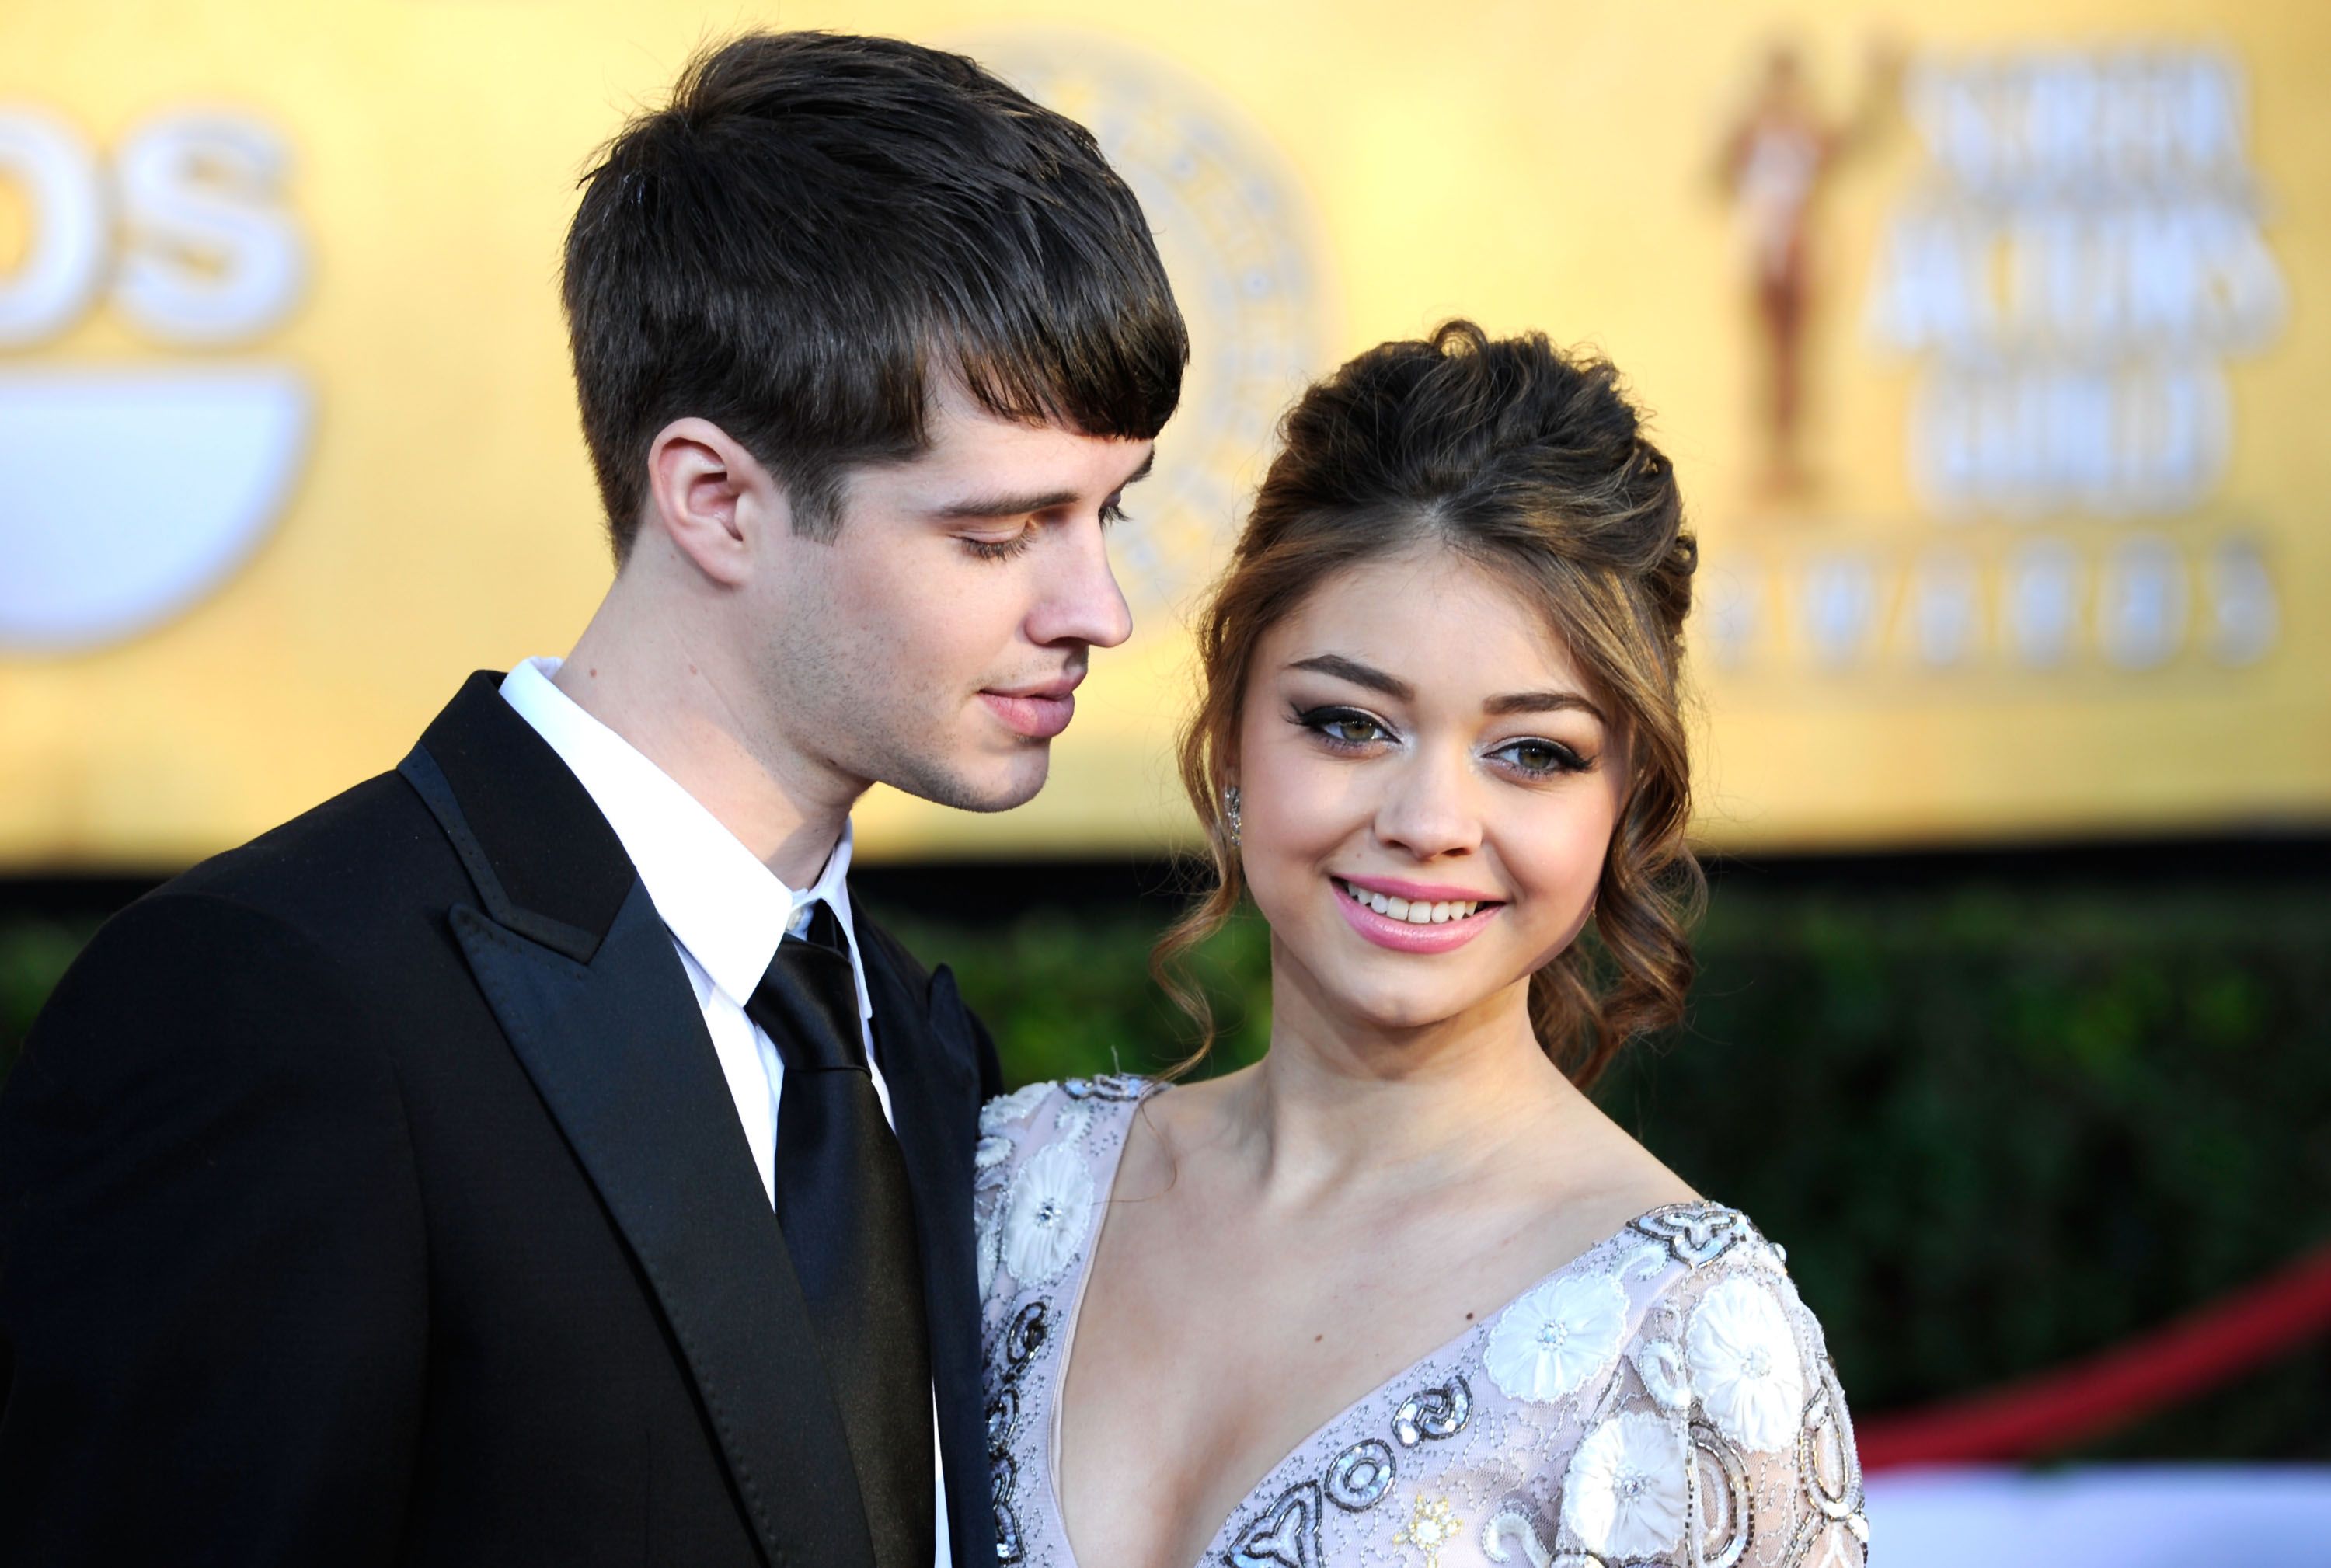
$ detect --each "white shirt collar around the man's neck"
[501,660,874,1018]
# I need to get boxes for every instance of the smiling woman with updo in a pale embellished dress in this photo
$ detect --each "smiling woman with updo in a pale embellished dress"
[974,322,1867,1568]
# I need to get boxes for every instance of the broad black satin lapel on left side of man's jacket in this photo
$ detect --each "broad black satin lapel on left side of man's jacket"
[452,880,876,1568]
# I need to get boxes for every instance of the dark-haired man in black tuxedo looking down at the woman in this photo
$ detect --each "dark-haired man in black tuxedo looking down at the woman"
[0,33,1186,1568]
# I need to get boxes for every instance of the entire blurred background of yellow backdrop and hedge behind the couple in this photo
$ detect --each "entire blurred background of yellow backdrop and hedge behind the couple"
[0,0,2331,1566]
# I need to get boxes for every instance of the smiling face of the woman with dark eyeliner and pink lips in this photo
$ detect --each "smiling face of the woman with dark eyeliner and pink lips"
[1259,543,1625,997]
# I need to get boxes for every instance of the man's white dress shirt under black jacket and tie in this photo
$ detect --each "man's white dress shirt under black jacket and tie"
[501,660,951,1568]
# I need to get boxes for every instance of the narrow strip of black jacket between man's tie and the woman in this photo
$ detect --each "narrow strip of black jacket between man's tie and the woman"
[858,925,995,1568]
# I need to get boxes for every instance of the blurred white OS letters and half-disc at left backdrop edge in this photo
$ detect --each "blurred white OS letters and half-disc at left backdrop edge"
[0,103,310,653]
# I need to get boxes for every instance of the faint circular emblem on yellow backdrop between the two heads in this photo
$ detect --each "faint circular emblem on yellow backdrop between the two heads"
[963,28,1333,608]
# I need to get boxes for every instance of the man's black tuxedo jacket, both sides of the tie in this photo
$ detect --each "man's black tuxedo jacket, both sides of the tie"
[0,674,998,1568]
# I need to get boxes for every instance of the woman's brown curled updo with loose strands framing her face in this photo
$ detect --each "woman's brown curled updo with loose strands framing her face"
[1152,322,1704,1085]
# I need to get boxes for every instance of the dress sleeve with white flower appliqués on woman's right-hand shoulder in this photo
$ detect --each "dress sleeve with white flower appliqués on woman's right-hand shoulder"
[1485,1204,1869,1568]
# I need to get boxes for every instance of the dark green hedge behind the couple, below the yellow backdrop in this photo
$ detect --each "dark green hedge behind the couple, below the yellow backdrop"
[0,878,2331,1458]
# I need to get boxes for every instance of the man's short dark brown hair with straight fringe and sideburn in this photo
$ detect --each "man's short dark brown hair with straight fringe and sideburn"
[562,33,1189,562]
